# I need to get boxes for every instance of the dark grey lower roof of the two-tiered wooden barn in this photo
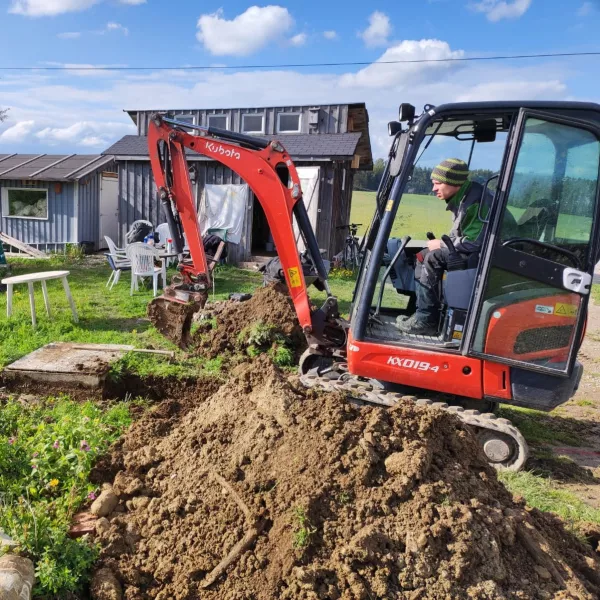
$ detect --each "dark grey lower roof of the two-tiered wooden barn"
[103,132,362,165]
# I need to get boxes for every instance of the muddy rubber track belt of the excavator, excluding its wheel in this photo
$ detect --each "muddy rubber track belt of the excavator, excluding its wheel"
[300,373,529,471]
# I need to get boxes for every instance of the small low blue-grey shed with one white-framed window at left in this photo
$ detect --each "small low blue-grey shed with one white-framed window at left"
[0,154,117,252]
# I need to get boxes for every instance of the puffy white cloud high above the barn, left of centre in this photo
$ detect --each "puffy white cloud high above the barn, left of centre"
[196,6,294,56]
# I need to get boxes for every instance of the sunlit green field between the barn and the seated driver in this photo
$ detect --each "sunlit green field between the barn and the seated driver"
[350,191,452,240]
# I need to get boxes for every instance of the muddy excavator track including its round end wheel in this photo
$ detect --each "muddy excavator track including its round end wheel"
[300,369,529,471]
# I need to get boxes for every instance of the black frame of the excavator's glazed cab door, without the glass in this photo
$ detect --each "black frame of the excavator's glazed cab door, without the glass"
[462,108,600,377]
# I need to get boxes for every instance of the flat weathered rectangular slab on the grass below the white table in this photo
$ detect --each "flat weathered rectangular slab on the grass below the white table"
[4,342,133,388]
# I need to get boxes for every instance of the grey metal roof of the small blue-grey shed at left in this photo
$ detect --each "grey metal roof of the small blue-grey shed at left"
[0,154,113,181]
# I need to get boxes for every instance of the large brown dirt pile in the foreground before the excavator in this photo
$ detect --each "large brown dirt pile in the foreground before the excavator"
[92,358,600,600]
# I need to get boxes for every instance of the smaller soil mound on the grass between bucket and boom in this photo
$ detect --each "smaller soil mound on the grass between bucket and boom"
[192,283,306,358]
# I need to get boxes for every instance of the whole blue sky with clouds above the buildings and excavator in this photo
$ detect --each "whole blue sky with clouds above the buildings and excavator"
[0,0,600,156]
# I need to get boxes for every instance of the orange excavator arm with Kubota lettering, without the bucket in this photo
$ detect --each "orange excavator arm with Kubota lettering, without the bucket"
[148,114,344,346]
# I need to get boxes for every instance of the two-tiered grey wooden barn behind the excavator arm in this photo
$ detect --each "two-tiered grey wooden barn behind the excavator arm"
[103,103,373,263]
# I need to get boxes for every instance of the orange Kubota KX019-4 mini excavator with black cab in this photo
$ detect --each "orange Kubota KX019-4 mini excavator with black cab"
[148,102,600,470]
